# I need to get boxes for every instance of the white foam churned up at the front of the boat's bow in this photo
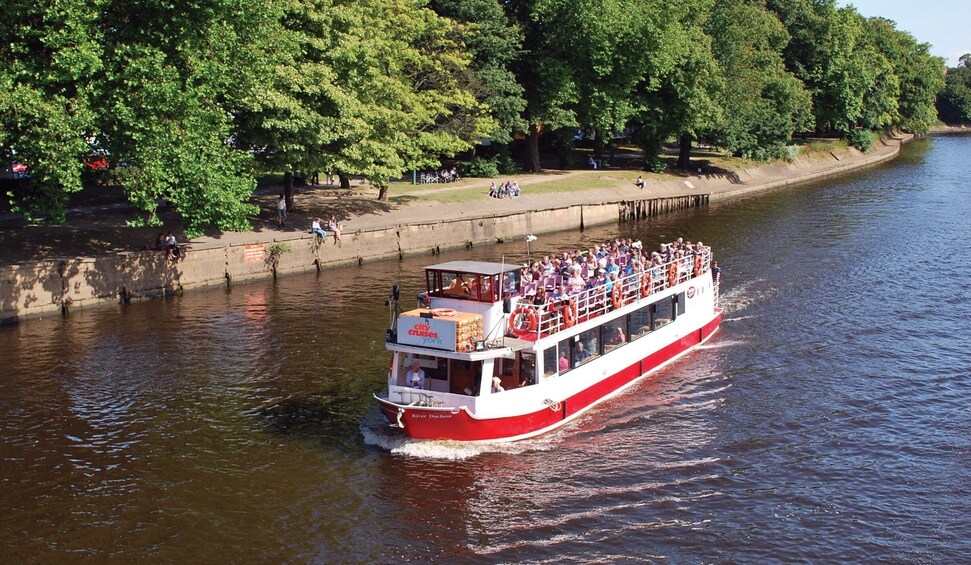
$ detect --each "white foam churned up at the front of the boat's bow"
[360,420,552,461]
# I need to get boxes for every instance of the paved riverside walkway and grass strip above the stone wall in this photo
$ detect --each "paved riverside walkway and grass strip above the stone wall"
[0,139,902,265]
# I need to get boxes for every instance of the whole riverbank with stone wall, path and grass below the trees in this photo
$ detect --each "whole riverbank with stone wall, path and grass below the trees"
[0,136,910,321]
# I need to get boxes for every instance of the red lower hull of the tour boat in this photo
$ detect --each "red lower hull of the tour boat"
[376,310,722,441]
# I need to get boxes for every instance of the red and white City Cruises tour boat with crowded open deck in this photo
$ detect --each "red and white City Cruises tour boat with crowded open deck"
[375,238,722,441]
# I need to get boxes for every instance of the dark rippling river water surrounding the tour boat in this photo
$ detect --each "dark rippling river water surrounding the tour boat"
[0,137,971,563]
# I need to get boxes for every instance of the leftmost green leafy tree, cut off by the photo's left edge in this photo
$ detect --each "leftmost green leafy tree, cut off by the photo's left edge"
[0,0,104,222]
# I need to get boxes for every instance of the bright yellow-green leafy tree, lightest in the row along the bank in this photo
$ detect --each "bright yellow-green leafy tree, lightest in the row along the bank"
[240,0,495,199]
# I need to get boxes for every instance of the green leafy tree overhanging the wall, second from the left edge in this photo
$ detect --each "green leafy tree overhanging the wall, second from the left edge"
[95,0,274,236]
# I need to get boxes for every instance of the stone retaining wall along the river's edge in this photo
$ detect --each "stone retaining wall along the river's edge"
[0,136,912,322]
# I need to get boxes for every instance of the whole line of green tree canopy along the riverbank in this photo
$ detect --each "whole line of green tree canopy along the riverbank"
[0,0,952,235]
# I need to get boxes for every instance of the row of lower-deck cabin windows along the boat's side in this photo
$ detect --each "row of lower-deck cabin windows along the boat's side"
[543,292,685,377]
